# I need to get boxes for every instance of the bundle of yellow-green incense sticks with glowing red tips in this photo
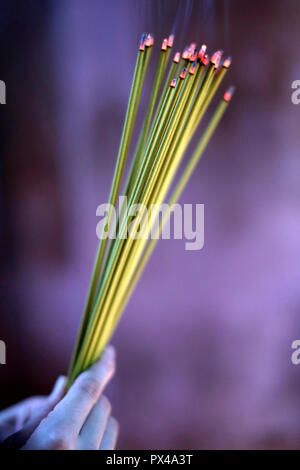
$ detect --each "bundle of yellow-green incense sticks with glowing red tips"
[68,34,234,386]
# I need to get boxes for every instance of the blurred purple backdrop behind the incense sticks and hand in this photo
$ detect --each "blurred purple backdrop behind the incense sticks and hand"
[0,0,300,449]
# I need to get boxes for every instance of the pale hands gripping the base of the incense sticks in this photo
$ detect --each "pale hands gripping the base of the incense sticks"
[0,346,118,450]
